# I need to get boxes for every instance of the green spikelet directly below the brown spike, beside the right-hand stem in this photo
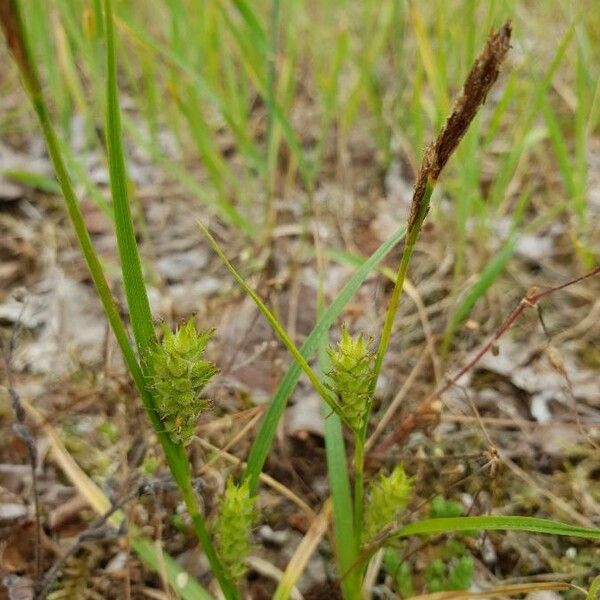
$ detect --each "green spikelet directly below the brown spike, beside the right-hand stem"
[327,327,373,433]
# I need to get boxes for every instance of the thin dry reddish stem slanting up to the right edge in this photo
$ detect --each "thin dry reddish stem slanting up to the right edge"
[373,266,600,455]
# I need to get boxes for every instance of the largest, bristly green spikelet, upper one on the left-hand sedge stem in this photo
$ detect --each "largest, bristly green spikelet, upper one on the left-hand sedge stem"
[148,317,218,445]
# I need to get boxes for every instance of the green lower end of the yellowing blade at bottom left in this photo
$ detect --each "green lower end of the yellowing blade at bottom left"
[130,535,213,600]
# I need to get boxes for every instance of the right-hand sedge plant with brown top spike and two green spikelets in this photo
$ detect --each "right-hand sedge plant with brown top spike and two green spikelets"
[200,23,600,599]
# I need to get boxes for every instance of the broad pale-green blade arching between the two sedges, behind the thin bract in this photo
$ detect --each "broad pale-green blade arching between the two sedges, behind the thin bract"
[245,227,406,493]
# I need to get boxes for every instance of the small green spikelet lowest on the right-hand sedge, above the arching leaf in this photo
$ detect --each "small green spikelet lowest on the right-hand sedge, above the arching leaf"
[363,465,413,542]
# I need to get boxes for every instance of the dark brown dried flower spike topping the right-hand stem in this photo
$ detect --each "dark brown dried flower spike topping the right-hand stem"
[408,21,512,231]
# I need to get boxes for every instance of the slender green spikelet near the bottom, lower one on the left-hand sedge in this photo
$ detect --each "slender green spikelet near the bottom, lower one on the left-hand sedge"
[214,478,256,582]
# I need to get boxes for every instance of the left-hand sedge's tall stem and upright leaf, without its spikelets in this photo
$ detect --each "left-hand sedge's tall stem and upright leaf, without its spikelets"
[0,0,238,598]
